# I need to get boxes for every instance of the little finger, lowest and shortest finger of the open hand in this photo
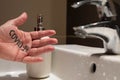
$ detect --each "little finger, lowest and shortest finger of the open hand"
[22,56,43,63]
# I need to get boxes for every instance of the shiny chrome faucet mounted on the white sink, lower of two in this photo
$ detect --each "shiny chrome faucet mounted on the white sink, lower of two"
[73,21,120,54]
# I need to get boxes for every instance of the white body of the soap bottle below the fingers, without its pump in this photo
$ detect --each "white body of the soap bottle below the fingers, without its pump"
[27,53,51,79]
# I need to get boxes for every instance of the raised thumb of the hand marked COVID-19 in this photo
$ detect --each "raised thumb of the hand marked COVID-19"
[13,12,27,26]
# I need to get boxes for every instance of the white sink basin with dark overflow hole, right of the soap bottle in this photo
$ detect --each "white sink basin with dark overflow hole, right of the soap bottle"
[52,45,120,80]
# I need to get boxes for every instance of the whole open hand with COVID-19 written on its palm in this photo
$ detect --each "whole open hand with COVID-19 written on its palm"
[0,13,57,63]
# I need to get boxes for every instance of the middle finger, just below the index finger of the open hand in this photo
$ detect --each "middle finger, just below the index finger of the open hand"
[32,38,58,48]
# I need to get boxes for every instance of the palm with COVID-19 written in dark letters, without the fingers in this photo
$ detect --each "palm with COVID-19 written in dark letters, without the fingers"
[0,22,32,60]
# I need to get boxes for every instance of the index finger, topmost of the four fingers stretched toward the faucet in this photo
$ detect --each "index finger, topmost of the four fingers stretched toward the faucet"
[30,30,56,40]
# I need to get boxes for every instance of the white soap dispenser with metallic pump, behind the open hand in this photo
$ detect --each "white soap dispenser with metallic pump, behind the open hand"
[26,15,51,79]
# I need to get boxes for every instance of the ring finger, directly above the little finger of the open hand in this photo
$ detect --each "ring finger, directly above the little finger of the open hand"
[28,45,54,56]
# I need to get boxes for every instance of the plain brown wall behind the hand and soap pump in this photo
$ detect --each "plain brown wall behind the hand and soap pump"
[0,0,66,44]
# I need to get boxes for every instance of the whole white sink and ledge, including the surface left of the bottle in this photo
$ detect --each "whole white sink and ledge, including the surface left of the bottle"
[0,45,120,80]
